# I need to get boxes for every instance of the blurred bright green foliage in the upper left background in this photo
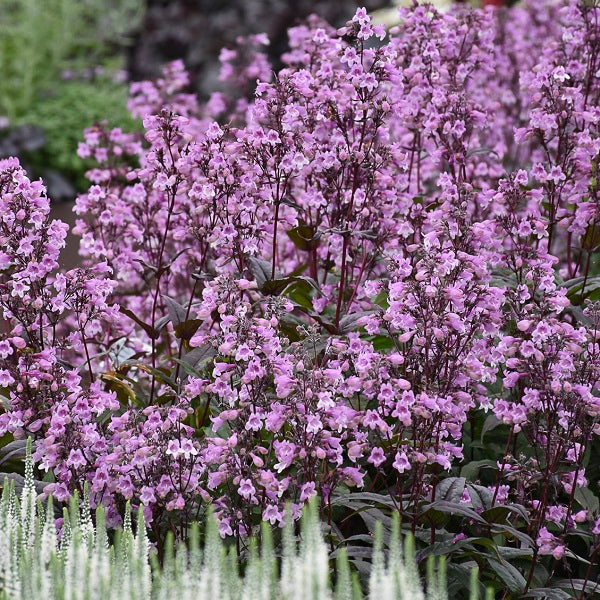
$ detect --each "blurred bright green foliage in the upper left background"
[0,0,145,190]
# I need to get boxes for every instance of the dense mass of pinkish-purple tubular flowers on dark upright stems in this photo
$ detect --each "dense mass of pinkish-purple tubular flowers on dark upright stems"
[0,0,600,587]
